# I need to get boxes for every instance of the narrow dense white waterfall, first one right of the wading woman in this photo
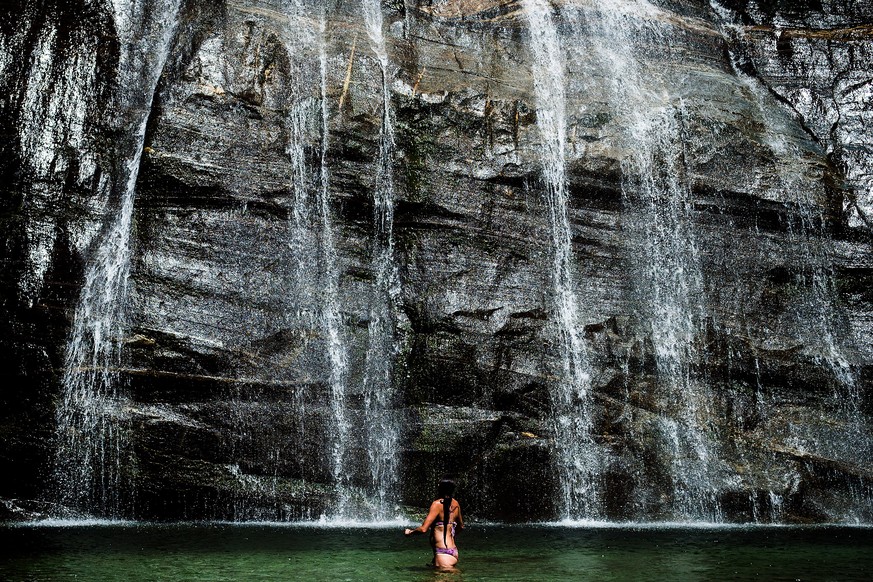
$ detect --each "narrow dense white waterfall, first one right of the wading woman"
[525,0,603,519]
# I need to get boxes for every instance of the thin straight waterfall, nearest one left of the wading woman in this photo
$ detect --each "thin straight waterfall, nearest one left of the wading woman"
[362,0,400,519]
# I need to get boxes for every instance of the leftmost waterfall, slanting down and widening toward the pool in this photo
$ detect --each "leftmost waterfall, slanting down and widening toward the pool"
[54,0,180,517]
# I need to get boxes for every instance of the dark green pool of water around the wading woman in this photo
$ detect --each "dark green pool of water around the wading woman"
[0,525,873,582]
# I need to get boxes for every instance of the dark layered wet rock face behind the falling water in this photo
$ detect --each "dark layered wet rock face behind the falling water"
[0,0,873,522]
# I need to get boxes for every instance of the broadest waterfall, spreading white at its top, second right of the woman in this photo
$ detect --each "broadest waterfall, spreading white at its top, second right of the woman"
[576,0,722,521]
